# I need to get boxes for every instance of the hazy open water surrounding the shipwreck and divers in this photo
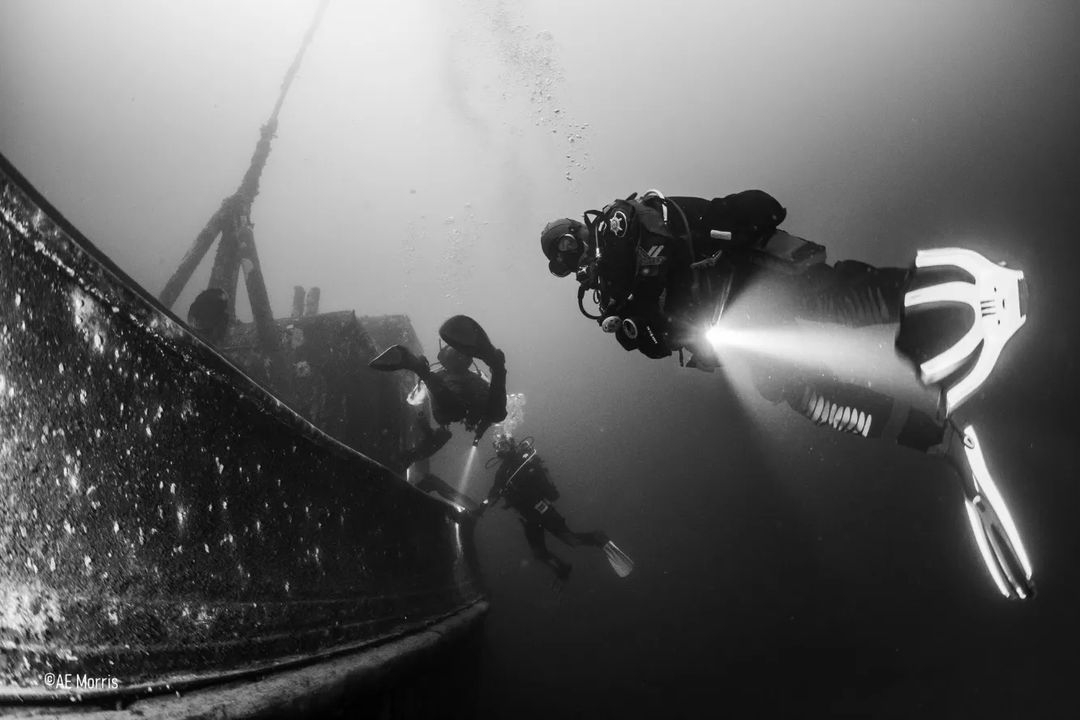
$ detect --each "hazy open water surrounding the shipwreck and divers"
[0,0,1080,718]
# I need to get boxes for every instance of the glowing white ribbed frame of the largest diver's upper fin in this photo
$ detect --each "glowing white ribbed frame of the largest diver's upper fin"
[901,247,1027,418]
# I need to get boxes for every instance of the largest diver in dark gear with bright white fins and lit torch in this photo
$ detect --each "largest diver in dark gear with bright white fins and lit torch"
[540,190,1035,599]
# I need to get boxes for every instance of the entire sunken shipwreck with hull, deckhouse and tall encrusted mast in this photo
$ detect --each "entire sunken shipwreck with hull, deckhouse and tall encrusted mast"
[0,0,487,717]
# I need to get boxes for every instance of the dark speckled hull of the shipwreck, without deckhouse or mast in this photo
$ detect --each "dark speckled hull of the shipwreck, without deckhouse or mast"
[0,158,485,702]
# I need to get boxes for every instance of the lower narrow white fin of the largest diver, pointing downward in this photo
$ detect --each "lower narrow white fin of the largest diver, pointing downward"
[936,422,1035,600]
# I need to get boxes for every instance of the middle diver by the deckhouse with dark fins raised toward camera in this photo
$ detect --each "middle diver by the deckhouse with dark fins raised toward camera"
[368,315,507,467]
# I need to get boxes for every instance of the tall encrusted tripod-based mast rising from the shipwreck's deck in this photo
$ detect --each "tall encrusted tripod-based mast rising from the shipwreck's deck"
[158,0,329,357]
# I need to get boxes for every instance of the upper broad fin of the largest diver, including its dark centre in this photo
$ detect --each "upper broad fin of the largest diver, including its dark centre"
[896,247,1027,418]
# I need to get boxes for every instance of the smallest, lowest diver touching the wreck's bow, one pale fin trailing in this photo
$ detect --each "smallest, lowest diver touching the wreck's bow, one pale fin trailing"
[473,433,634,588]
